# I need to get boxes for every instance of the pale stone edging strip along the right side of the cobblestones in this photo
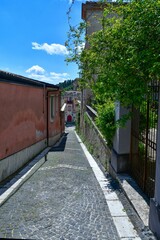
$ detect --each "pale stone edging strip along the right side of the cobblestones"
[75,132,141,240]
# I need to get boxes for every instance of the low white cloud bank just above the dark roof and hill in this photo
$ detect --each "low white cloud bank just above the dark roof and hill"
[26,65,69,84]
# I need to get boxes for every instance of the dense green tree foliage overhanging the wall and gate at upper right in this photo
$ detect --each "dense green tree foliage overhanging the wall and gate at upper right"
[66,0,160,142]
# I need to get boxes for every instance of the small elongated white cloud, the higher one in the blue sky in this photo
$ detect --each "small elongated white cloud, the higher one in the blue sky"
[32,42,68,55]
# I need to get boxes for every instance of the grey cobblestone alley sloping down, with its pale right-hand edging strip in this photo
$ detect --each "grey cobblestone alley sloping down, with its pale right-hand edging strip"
[0,127,156,240]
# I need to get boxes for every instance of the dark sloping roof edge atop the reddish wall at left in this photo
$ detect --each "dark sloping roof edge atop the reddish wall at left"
[0,70,59,89]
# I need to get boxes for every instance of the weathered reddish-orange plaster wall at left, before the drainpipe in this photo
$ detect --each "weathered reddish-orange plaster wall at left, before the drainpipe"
[0,82,47,159]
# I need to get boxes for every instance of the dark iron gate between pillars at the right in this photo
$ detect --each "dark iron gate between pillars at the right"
[130,81,159,197]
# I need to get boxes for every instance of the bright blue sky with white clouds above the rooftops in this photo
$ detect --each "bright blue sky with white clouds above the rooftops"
[0,0,85,84]
